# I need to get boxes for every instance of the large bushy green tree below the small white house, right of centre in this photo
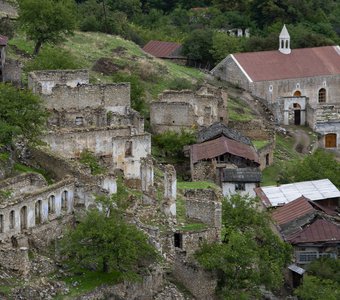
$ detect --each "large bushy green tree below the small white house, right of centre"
[195,195,291,299]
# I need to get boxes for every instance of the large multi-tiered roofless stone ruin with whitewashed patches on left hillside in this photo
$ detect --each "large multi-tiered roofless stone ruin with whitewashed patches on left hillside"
[28,70,151,179]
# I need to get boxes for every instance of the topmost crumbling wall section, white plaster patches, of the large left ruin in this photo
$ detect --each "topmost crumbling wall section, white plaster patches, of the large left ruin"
[28,70,90,94]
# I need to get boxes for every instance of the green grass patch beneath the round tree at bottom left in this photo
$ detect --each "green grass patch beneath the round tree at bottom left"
[54,271,119,300]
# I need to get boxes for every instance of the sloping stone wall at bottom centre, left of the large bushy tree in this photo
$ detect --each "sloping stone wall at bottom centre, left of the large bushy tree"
[172,251,217,300]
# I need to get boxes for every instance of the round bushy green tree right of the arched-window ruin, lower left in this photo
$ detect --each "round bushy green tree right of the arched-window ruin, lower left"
[61,180,157,280]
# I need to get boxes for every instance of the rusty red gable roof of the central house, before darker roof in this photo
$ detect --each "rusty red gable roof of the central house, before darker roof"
[191,136,259,163]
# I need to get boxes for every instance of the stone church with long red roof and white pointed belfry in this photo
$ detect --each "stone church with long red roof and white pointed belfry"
[211,26,340,149]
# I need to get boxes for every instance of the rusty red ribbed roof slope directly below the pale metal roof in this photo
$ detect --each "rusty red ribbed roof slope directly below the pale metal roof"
[272,196,315,225]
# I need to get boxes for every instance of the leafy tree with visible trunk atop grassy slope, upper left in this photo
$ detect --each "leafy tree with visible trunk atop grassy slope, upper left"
[18,0,76,55]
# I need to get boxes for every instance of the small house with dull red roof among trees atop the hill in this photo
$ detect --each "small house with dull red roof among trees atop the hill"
[143,41,187,65]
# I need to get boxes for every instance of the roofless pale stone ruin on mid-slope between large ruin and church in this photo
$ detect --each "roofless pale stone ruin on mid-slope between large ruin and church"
[150,87,228,133]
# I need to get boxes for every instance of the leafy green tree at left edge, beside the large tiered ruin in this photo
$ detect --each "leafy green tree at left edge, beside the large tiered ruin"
[0,83,47,145]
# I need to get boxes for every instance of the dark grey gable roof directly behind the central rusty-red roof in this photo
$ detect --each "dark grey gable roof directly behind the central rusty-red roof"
[197,122,251,145]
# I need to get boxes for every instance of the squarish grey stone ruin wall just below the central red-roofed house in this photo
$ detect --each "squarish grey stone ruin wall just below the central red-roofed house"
[184,189,222,228]
